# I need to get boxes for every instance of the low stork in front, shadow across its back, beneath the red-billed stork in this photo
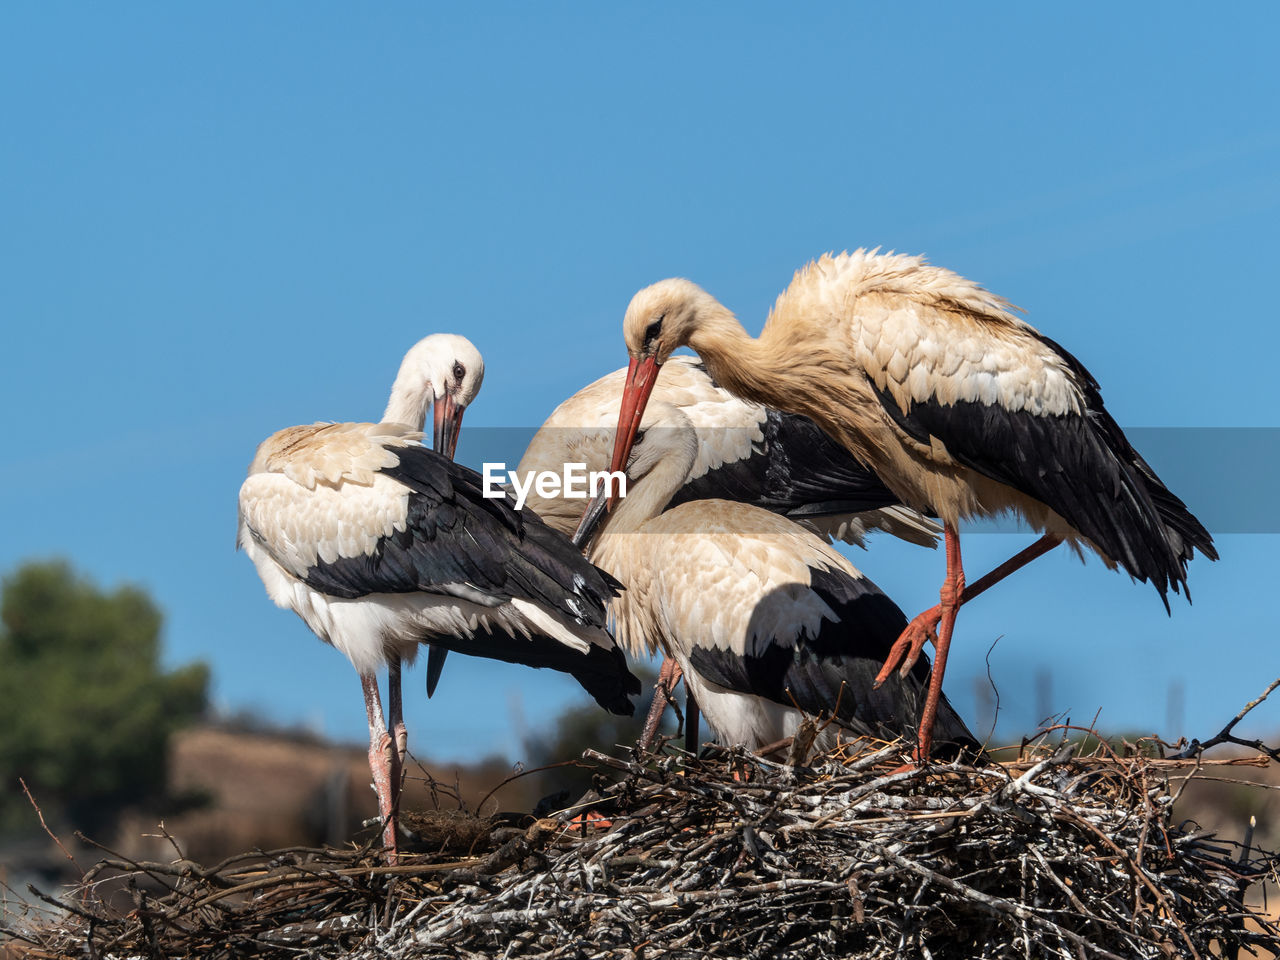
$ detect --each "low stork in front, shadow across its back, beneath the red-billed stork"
[576,403,977,749]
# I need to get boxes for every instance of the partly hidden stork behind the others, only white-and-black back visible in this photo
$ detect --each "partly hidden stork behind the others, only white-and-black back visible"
[516,357,942,547]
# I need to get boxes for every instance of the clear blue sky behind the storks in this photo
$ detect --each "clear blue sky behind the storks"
[0,3,1280,759]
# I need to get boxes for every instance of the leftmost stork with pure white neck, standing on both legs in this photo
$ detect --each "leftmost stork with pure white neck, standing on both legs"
[237,348,640,861]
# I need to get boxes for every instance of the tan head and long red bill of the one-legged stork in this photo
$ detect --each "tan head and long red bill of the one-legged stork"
[609,278,726,481]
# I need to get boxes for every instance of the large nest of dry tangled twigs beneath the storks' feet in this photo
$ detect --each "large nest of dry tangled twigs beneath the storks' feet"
[8,741,1280,960]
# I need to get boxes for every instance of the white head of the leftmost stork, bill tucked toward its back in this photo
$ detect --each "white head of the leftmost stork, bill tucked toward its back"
[383,333,484,460]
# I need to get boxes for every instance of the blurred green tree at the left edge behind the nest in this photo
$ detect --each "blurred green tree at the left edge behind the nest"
[0,561,209,833]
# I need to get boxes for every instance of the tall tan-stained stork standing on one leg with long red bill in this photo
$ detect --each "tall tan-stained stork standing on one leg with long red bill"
[611,251,1217,758]
